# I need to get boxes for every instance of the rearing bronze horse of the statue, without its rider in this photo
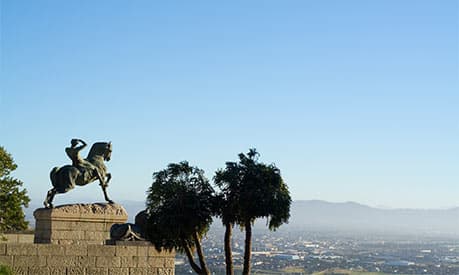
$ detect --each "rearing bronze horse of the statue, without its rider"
[43,142,113,208]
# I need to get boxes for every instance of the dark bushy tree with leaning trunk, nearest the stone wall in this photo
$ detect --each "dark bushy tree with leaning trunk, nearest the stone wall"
[146,161,214,274]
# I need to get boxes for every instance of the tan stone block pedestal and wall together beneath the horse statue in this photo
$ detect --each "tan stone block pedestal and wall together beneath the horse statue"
[0,203,175,275]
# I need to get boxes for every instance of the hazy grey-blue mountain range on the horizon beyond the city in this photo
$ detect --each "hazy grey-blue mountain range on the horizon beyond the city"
[26,200,459,237]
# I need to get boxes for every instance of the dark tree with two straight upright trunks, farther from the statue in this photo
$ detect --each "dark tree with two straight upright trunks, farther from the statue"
[215,149,292,274]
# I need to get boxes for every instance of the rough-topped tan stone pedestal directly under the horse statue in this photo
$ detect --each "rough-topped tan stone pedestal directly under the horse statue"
[33,203,128,244]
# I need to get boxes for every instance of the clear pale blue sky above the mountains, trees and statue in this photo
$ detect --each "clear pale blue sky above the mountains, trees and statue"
[0,0,459,208]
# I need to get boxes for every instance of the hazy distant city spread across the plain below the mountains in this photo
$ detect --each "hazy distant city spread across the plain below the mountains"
[175,228,459,275]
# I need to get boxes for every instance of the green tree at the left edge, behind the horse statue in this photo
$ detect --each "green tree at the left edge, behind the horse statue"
[0,146,30,233]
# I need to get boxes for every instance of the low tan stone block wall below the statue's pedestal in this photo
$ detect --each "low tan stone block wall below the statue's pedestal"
[0,243,175,275]
